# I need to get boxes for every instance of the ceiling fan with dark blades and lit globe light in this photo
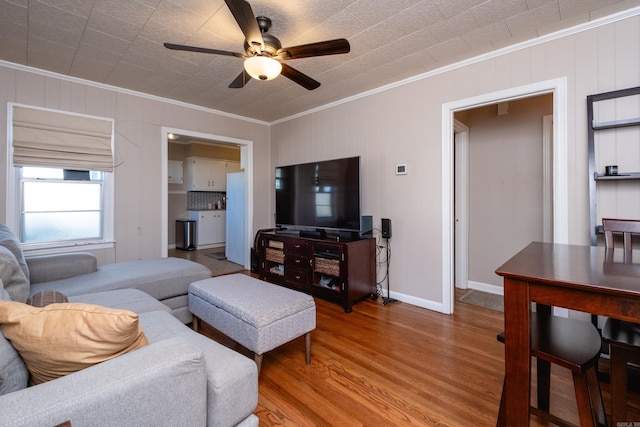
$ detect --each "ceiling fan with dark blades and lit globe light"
[164,0,351,90]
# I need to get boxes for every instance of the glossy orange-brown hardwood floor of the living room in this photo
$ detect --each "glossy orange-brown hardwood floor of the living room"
[170,251,640,427]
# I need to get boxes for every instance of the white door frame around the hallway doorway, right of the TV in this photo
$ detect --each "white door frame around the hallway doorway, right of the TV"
[441,77,569,314]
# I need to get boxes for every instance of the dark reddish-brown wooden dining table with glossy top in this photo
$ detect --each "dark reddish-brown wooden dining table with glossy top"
[496,242,640,426]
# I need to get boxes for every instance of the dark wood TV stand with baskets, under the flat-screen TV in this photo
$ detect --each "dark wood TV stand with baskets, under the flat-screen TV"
[258,233,378,313]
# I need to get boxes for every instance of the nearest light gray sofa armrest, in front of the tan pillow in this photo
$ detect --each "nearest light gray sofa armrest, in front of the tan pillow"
[0,337,207,427]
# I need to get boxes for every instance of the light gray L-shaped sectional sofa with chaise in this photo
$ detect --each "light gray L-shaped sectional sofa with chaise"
[0,226,258,427]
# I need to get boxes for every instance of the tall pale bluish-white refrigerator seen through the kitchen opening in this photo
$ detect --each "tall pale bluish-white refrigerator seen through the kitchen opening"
[225,172,249,266]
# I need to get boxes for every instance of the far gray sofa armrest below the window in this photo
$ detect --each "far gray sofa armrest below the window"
[26,252,98,284]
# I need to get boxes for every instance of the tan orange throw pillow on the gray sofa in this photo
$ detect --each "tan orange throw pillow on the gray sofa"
[0,301,148,384]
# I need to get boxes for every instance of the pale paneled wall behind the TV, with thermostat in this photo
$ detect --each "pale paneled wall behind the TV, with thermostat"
[269,12,640,307]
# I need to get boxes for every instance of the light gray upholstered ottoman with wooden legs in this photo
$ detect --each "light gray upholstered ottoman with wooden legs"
[189,274,316,372]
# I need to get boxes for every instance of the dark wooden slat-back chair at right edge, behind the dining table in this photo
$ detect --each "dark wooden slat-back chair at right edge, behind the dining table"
[602,218,640,426]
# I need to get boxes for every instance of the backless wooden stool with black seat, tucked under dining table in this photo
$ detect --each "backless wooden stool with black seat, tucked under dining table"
[496,313,607,426]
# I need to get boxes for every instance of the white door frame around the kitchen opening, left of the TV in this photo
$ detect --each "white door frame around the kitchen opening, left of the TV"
[161,126,253,270]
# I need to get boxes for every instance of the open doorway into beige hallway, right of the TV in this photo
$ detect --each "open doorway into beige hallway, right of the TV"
[454,94,553,295]
